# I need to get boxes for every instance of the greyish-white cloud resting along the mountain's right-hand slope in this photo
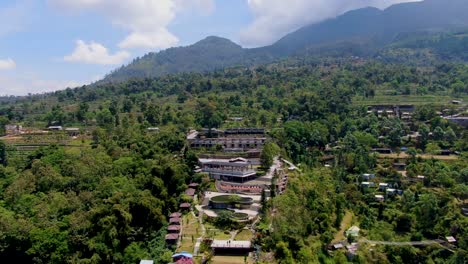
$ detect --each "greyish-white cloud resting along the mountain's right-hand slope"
[240,0,420,47]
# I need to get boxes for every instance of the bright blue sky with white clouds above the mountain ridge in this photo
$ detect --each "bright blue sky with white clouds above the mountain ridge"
[0,0,416,95]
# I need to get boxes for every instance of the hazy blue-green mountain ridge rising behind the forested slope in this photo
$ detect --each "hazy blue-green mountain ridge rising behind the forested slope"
[103,0,468,82]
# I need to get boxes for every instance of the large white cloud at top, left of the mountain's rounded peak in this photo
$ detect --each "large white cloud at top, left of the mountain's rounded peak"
[48,0,214,49]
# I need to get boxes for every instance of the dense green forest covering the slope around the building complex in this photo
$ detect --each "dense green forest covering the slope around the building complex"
[0,57,468,263]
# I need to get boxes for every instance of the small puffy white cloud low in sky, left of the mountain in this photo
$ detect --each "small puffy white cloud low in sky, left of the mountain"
[63,40,130,65]
